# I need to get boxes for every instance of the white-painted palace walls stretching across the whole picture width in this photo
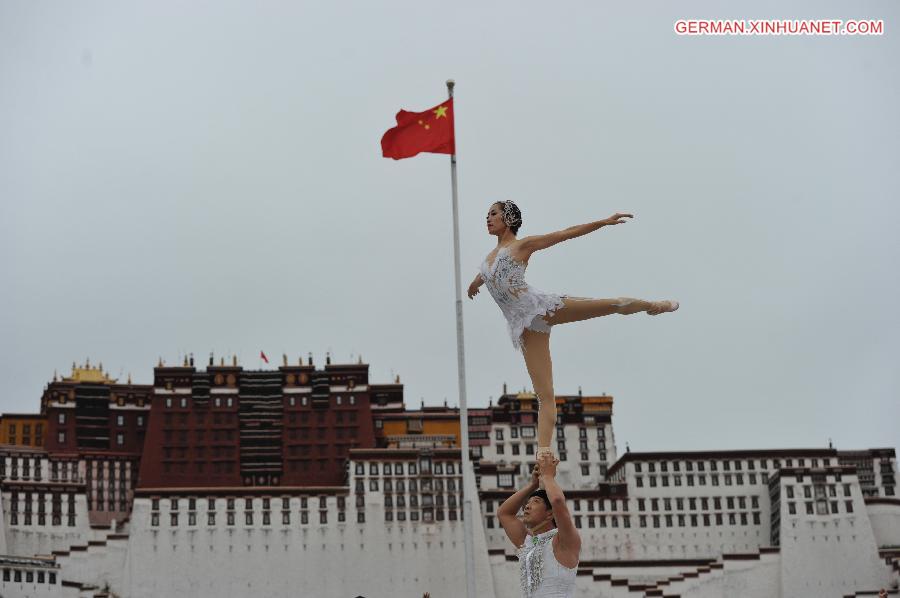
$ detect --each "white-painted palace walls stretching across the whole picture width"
[0,442,900,598]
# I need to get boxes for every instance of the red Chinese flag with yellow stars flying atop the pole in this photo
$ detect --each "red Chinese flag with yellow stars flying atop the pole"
[381,98,456,160]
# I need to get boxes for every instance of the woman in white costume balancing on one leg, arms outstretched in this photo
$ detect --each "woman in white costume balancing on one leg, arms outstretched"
[468,201,678,459]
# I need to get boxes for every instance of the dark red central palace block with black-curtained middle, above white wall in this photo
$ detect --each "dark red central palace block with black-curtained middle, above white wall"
[138,364,375,488]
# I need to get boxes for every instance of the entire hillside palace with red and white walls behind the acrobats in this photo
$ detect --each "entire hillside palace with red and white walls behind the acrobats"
[0,356,900,598]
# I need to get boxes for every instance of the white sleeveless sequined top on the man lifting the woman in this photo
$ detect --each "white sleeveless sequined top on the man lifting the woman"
[518,529,577,598]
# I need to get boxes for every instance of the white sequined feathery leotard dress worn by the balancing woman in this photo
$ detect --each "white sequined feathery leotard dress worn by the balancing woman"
[481,247,568,350]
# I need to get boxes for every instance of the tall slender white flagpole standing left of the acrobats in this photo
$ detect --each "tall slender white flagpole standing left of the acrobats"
[447,79,477,598]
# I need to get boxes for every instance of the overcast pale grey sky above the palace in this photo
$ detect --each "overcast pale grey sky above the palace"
[0,0,900,451]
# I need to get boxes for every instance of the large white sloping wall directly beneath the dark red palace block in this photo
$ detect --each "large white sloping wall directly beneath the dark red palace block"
[122,460,494,598]
